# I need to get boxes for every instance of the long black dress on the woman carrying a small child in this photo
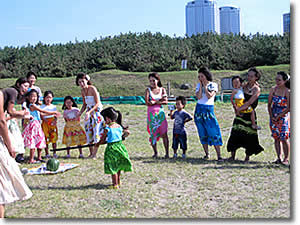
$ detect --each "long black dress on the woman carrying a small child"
[227,93,264,156]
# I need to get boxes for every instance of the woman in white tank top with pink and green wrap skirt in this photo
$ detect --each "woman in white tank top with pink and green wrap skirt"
[145,73,169,158]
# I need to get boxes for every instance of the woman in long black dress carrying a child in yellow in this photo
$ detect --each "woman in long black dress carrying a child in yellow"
[227,67,264,162]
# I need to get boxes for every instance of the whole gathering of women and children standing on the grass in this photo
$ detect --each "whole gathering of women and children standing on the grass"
[0,67,290,217]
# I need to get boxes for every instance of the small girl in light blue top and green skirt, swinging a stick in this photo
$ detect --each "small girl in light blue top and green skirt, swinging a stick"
[99,107,132,189]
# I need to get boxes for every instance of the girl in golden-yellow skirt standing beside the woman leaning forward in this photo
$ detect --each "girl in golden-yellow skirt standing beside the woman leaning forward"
[62,96,86,158]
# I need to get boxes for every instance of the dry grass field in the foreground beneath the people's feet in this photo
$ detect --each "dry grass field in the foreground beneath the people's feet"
[6,101,291,218]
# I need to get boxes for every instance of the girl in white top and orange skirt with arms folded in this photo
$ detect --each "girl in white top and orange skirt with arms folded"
[41,91,58,158]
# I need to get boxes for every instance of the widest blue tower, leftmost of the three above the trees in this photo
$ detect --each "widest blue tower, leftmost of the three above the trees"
[185,0,220,36]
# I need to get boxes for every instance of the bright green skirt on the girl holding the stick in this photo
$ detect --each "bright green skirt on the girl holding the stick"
[104,141,132,175]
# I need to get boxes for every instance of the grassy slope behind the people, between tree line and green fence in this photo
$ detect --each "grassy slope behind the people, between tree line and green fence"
[0,65,290,97]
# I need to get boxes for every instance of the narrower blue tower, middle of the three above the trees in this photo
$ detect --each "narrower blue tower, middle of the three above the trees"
[219,6,241,34]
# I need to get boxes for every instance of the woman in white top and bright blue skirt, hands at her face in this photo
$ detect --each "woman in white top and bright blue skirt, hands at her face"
[194,67,223,161]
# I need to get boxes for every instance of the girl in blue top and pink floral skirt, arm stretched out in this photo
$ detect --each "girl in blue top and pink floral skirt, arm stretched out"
[22,89,60,163]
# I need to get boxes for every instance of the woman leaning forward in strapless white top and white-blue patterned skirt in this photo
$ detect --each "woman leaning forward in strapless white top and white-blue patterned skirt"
[76,73,104,158]
